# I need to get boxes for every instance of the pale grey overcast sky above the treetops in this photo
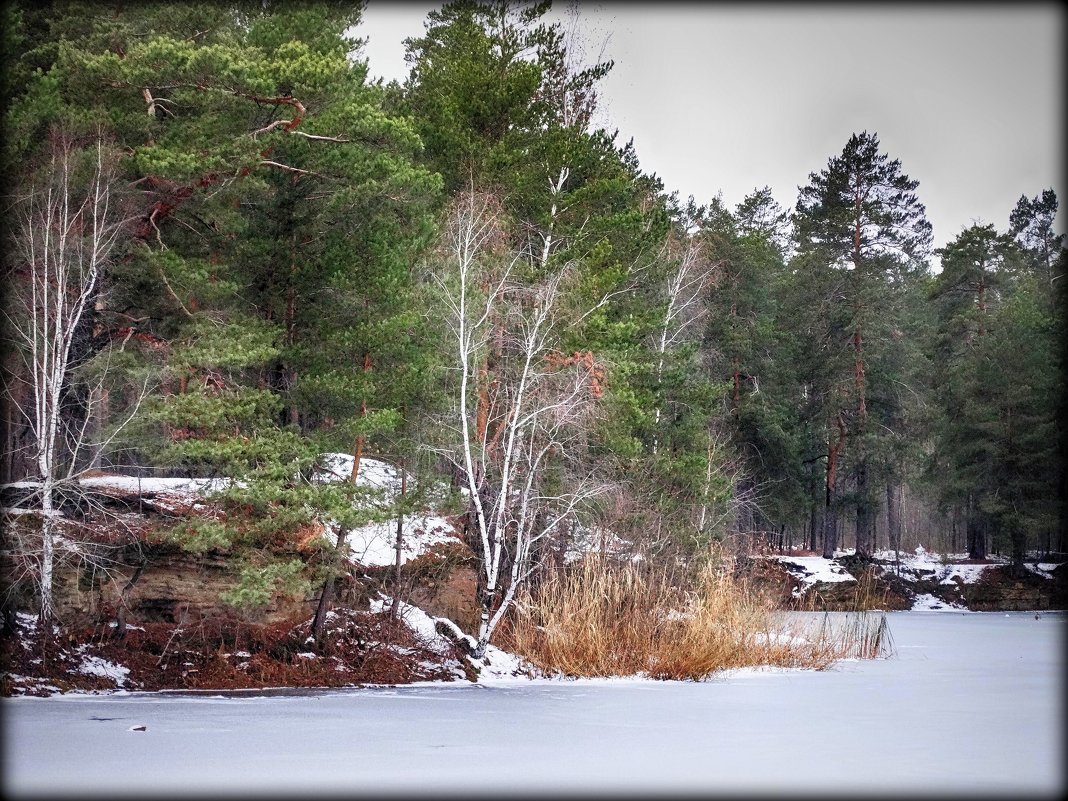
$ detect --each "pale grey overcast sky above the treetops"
[359,0,1068,252]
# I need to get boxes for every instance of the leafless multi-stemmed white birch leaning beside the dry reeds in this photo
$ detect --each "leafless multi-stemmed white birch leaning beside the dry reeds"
[436,191,600,657]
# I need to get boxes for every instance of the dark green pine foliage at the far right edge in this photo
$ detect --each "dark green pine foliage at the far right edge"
[930,207,1064,562]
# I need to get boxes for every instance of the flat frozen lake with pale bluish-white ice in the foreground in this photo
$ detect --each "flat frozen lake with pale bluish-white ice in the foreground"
[2,612,1066,798]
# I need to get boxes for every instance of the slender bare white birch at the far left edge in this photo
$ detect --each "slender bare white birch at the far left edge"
[9,135,124,621]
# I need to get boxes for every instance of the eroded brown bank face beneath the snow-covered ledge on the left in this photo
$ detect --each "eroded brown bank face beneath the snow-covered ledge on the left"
[0,496,478,631]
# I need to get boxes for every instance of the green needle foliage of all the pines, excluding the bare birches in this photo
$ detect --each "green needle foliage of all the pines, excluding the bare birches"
[3,0,1068,609]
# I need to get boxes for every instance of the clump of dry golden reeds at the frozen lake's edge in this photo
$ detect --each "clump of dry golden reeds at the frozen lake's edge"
[502,554,885,679]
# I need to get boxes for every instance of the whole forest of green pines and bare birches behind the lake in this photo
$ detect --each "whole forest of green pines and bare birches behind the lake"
[2,0,1068,623]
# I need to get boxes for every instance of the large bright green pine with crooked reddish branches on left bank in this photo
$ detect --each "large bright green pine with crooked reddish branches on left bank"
[5,3,440,627]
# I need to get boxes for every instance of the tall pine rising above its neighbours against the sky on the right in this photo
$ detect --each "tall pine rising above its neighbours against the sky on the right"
[788,131,931,553]
